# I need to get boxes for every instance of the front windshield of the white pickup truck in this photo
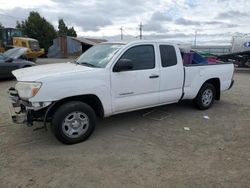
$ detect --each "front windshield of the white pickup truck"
[76,44,122,68]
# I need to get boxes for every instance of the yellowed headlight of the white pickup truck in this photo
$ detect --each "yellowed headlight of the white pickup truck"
[15,82,42,99]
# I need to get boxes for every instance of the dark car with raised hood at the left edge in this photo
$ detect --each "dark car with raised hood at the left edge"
[0,48,35,78]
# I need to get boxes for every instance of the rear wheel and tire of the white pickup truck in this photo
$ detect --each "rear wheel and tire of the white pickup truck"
[193,83,215,110]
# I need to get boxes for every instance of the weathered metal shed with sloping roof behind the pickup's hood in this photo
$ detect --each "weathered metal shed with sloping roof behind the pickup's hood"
[47,36,107,58]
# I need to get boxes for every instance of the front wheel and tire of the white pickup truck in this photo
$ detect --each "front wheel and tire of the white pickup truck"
[52,101,96,144]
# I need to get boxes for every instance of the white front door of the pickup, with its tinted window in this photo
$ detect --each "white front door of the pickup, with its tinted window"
[111,44,160,113]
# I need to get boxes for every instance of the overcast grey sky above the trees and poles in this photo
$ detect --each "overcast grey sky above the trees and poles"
[0,0,250,44]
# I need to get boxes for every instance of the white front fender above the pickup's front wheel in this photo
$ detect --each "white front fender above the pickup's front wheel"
[29,73,111,116]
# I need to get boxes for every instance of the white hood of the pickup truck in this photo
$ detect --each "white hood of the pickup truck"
[12,62,94,81]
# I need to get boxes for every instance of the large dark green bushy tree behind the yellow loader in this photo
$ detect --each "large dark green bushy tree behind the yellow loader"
[16,11,57,52]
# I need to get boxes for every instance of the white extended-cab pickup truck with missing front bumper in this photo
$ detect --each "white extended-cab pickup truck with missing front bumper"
[8,41,234,144]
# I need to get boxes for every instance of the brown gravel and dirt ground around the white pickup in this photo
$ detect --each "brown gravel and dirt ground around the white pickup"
[0,60,250,188]
